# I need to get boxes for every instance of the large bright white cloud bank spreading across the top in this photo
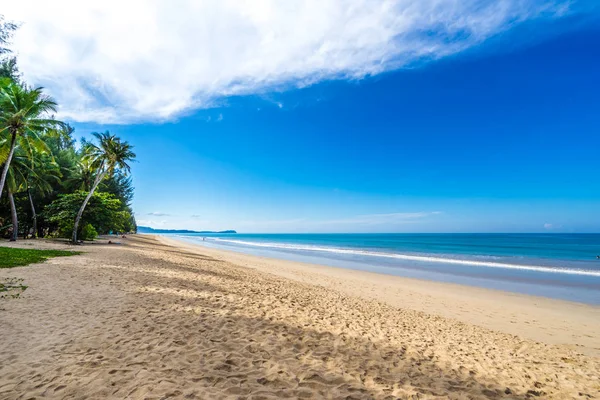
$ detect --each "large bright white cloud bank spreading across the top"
[0,0,571,123]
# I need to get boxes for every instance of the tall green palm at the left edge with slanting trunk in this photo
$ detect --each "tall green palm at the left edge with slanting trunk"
[0,79,62,196]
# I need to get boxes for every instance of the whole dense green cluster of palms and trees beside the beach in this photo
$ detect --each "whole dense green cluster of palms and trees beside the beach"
[0,15,137,243]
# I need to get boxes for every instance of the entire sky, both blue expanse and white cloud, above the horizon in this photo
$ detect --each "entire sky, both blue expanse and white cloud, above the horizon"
[0,0,600,232]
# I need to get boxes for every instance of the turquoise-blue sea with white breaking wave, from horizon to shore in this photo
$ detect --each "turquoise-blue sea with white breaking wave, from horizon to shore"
[166,234,600,304]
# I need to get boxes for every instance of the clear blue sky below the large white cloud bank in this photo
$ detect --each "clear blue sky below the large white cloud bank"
[4,2,600,232]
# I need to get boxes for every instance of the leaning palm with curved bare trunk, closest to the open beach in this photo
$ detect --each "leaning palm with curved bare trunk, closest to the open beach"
[72,132,135,243]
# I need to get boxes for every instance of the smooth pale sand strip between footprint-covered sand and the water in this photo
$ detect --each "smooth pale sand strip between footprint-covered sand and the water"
[159,235,600,356]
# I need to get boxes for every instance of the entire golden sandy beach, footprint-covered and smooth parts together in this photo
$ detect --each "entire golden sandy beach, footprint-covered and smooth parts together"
[0,235,600,399]
